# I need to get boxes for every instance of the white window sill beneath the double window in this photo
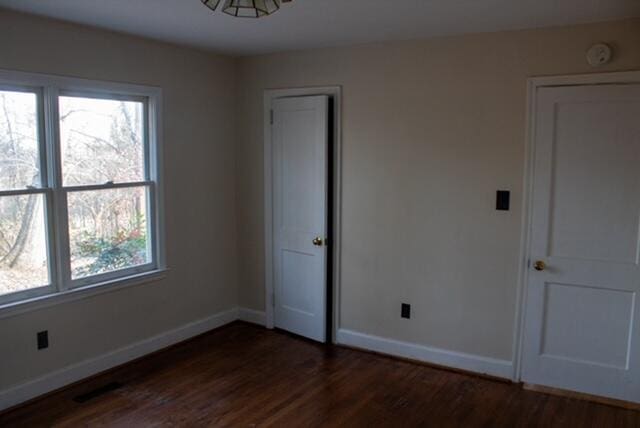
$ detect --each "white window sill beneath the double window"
[0,269,169,319]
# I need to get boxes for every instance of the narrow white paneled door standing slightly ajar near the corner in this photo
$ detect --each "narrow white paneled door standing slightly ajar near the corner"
[271,96,329,342]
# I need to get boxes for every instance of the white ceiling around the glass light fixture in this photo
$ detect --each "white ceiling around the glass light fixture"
[0,0,640,55]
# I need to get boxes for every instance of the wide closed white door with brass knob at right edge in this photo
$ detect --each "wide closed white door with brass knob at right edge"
[522,84,640,402]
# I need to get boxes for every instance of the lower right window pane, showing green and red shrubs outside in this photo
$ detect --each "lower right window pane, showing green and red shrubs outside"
[68,187,151,279]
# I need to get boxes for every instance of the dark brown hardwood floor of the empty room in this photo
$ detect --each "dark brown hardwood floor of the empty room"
[0,322,640,427]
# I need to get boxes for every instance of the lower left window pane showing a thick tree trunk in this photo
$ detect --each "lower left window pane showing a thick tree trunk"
[0,195,49,295]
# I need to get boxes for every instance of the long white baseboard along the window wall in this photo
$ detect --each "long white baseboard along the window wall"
[0,308,239,410]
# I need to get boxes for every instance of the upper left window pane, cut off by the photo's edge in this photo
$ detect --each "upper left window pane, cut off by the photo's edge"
[0,91,40,190]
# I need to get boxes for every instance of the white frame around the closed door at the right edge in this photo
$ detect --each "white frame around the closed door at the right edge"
[512,71,640,382]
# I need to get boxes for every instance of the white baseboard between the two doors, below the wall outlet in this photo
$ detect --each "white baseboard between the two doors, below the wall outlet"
[337,329,513,379]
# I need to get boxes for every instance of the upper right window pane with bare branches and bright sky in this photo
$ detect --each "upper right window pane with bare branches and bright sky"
[59,96,145,186]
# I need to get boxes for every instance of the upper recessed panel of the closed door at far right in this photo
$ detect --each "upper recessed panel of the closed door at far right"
[549,100,640,264]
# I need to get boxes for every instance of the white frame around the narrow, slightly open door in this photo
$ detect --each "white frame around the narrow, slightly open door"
[263,86,342,341]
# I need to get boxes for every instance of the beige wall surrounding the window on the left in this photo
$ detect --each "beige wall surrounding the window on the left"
[0,11,237,390]
